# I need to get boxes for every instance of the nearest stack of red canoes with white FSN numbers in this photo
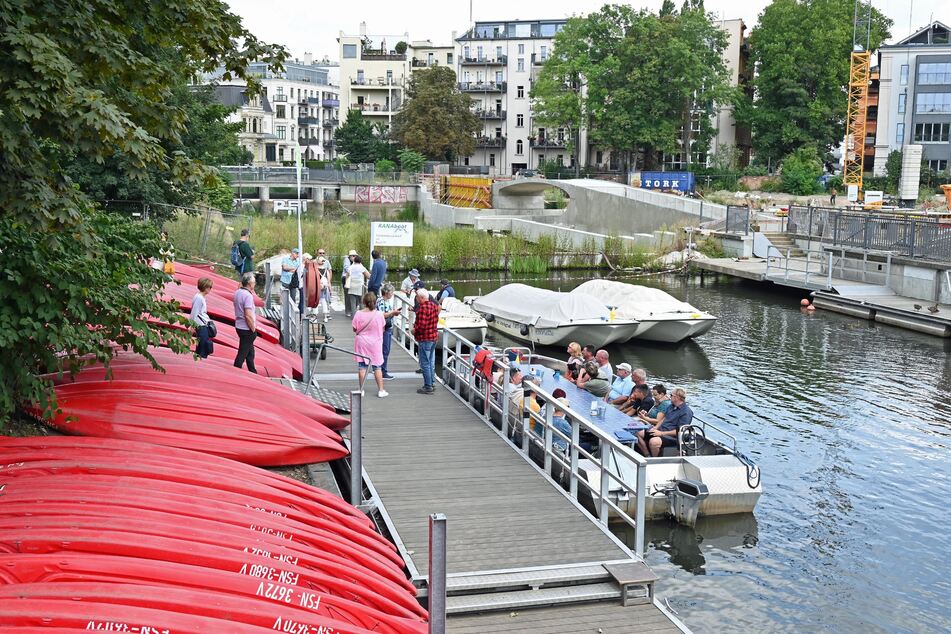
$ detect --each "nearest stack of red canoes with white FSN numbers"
[0,436,426,633]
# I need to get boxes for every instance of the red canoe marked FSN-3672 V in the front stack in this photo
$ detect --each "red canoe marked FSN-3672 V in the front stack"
[0,553,427,634]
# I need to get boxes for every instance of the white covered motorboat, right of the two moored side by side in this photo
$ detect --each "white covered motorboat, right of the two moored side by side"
[571,280,717,343]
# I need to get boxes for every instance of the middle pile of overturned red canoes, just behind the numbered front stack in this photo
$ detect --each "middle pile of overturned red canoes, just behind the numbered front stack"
[34,348,349,466]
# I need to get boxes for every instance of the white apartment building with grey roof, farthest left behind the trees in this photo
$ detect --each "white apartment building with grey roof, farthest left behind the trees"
[205,54,340,165]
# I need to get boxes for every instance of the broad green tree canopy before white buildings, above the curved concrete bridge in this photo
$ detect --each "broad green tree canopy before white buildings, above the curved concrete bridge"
[532,2,730,165]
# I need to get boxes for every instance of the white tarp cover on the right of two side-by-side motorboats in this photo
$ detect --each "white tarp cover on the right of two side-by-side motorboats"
[571,280,712,321]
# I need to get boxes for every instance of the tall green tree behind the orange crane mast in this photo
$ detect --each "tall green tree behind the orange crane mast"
[736,0,892,161]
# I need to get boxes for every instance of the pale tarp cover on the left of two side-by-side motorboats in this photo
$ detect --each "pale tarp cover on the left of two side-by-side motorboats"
[472,284,611,328]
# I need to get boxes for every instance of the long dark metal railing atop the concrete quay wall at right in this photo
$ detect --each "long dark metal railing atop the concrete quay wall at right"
[786,205,951,262]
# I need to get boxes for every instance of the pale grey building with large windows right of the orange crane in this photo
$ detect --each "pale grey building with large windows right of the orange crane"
[866,22,951,176]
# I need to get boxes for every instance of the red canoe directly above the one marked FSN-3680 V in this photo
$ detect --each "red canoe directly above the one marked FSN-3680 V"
[0,505,416,602]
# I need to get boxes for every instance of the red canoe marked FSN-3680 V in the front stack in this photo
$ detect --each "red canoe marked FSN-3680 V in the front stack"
[0,527,426,618]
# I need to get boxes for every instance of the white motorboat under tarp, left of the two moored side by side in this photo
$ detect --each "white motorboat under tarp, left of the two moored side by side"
[466,284,638,348]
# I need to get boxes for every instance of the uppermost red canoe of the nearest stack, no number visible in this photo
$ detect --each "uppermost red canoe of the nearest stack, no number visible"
[0,436,368,528]
